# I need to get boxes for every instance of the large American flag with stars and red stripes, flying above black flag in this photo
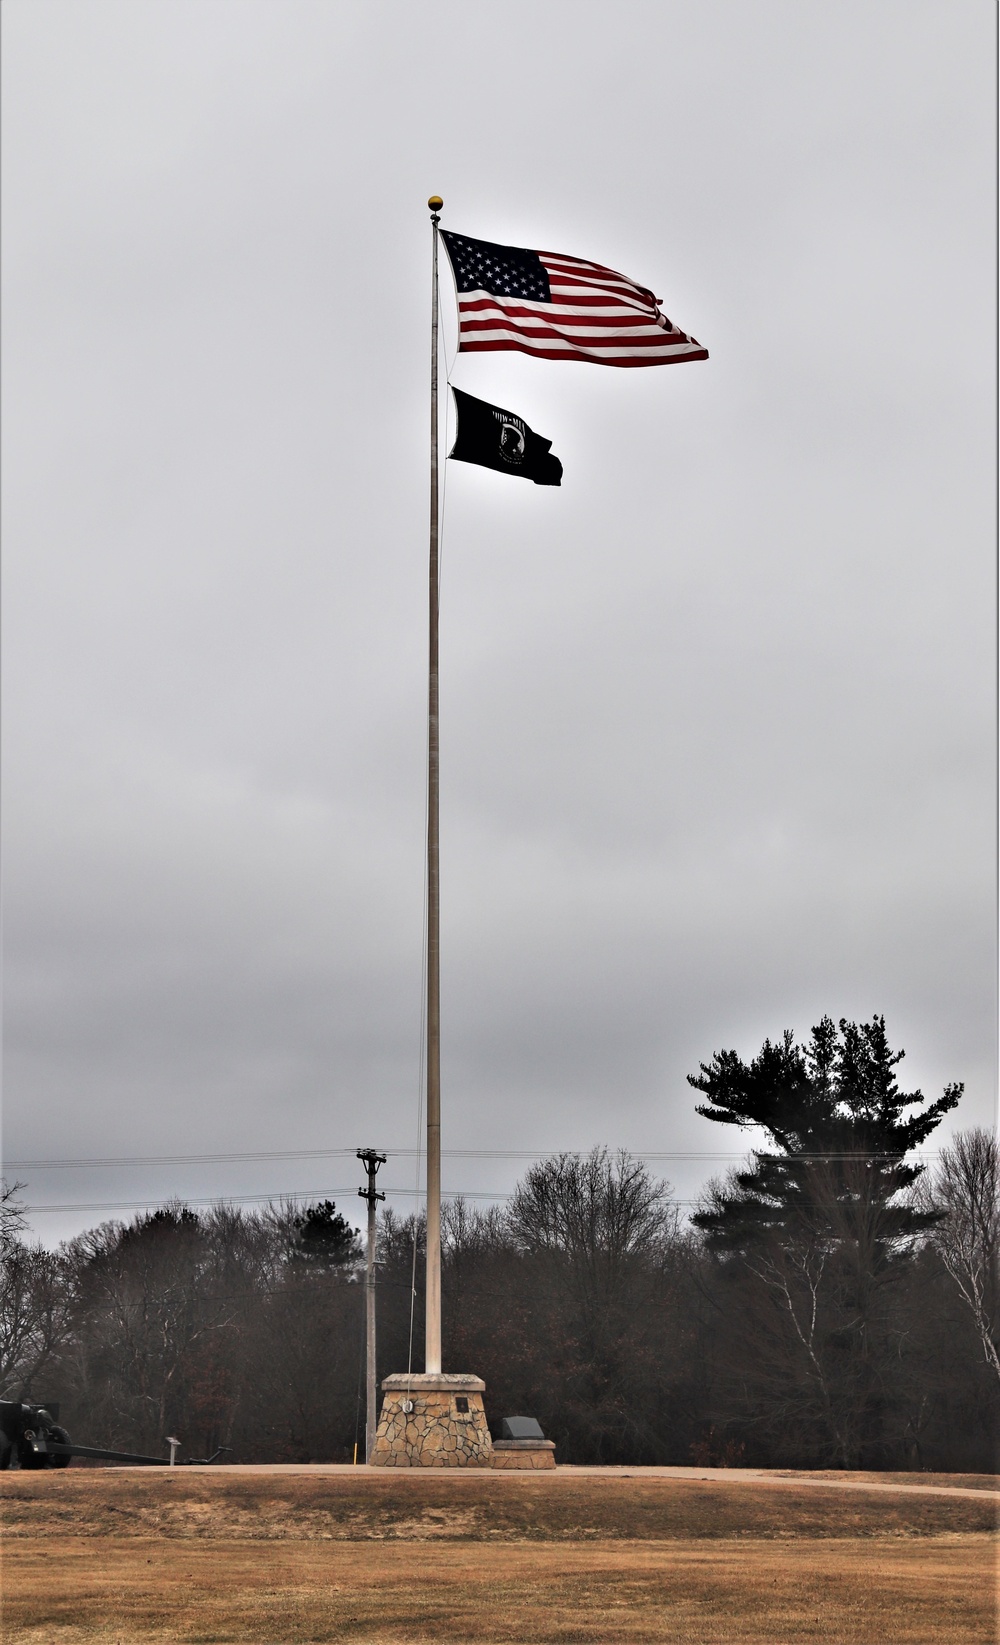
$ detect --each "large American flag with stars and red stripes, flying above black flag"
[441,229,709,365]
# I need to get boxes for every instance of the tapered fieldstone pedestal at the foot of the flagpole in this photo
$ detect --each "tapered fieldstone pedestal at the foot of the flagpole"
[370,1372,493,1467]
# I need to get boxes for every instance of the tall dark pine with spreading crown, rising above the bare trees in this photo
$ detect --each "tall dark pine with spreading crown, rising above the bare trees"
[689,1017,962,1467]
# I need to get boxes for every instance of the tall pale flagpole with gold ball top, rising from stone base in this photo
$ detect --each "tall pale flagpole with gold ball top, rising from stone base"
[424,194,444,1374]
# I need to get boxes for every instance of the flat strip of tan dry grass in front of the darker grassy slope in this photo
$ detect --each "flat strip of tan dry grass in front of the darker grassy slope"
[5,1536,993,1645]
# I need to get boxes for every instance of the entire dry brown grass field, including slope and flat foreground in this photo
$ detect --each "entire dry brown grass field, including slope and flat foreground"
[3,1469,997,1645]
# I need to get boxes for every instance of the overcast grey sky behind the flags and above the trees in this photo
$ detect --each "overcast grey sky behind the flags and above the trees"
[3,0,995,1242]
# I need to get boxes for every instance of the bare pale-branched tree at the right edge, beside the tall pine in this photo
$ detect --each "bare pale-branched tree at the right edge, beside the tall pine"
[914,1127,1000,1380]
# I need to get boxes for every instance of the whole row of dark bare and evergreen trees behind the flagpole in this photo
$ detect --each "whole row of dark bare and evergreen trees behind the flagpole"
[0,1018,1000,1471]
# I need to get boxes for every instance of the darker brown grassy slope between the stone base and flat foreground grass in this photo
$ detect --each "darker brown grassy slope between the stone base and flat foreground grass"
[0,1467,998,1543]
